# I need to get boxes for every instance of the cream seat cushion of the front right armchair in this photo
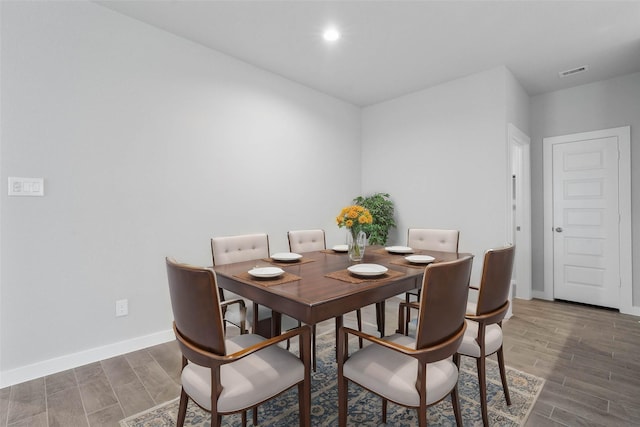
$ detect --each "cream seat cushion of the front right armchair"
[344,334,458,407]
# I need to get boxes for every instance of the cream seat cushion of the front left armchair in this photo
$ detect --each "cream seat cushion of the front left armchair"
[182,334,304,413]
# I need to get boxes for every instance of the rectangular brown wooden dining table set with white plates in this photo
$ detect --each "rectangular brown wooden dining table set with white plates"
[214,246,468,336]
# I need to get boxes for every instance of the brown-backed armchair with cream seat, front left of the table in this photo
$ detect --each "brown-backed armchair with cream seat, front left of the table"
[166,258,311,427]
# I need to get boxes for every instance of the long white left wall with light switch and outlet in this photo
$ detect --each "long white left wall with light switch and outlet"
[0,2,361,387]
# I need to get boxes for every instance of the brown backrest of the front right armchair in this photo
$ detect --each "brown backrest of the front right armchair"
[416,256,473,352]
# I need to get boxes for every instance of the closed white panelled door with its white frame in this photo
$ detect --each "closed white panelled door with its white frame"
[543,126,632,312]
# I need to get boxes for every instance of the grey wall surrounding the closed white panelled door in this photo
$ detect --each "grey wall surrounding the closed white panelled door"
[531,73,640,306]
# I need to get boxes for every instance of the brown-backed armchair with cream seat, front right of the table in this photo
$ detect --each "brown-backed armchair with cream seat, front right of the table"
[338,256,473,427]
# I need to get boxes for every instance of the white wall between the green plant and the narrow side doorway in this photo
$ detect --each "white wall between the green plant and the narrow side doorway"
[362,67,528,281]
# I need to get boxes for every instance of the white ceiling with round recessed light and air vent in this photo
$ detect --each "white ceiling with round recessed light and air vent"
[97,0,640,106]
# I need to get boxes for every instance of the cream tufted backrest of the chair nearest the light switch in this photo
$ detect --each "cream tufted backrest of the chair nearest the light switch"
[211,233,269,265]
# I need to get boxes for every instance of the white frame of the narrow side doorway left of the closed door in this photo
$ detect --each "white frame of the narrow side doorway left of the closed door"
[507,123,532,299]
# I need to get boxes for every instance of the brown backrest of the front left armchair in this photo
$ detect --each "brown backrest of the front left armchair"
[166,258,226,355]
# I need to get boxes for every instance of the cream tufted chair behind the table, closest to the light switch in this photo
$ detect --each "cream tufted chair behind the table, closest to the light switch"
[211,233,299,333]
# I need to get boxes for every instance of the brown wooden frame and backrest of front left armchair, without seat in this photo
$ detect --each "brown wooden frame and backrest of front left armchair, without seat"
[166,258,311,427]
